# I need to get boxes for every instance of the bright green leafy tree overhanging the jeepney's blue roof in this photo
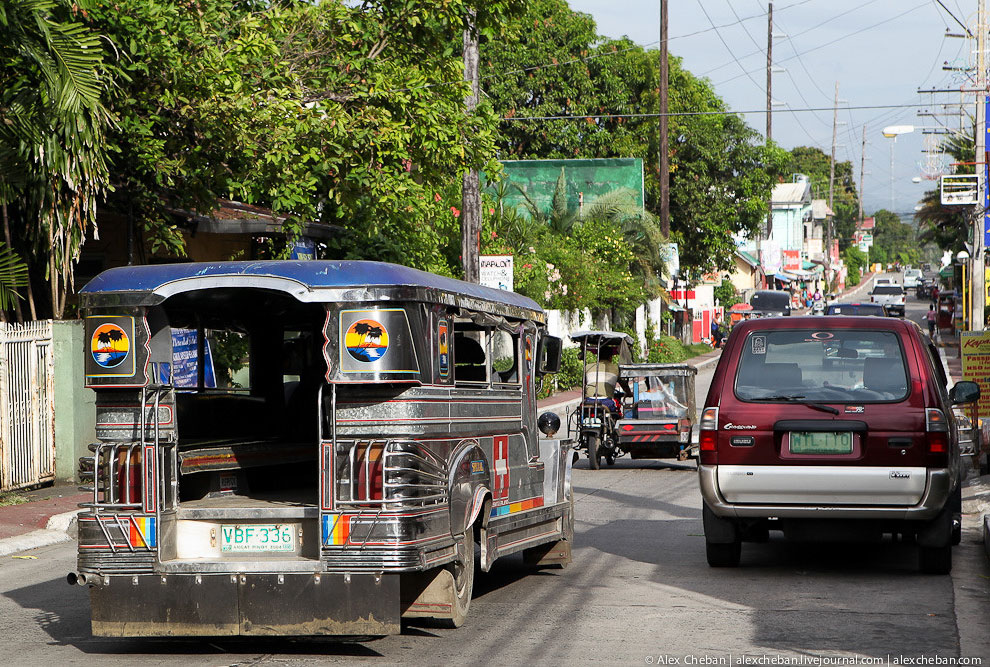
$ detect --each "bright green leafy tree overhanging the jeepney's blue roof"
[90,0,521,273]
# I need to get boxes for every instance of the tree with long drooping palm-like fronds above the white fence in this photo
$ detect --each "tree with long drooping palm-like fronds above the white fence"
[0,0,110,317]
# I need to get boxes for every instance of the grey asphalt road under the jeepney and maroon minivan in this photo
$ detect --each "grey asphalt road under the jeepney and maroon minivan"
[0,284,990,665]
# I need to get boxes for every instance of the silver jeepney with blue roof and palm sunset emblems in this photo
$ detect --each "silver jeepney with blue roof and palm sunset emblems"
[68,261,573,636]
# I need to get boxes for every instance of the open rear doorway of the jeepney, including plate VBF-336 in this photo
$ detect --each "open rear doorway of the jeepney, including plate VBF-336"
[140,288,326,562]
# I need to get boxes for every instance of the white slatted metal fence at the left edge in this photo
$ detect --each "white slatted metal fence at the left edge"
[0,320,55,491]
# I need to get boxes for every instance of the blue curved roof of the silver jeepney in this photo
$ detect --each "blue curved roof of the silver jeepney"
[80,260,545,322]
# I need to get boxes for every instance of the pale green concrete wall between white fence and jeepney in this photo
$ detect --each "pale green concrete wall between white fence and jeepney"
[52,320,96,481]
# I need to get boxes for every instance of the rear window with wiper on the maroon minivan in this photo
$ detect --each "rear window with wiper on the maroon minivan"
[735,329,908,403]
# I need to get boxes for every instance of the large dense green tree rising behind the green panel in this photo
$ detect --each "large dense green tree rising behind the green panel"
[481,0,787,274]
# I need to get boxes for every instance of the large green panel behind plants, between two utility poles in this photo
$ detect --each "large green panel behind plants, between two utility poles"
[502,158,644,217]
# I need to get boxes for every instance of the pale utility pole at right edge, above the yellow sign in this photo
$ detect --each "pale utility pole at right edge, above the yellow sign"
[969,0,987,331]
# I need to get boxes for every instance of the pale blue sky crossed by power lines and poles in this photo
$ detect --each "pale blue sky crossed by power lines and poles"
[570,0,976,216]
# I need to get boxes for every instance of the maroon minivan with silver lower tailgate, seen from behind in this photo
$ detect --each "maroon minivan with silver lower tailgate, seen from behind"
[698,316,979,573]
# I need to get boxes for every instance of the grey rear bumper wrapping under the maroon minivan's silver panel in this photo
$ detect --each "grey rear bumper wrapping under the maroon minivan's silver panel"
[698,465,952,521]
